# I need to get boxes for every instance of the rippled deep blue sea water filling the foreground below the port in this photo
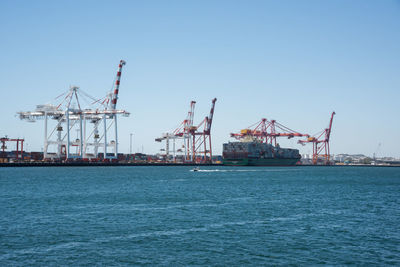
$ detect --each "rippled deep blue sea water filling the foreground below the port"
[0,167,400,266]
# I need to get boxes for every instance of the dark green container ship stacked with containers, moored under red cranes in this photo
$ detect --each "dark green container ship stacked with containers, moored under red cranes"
[222,141,301,166]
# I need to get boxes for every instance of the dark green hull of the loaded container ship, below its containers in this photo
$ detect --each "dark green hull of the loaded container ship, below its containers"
[223,158,300,166]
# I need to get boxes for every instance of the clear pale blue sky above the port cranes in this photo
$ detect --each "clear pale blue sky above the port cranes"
[0,0,400,157]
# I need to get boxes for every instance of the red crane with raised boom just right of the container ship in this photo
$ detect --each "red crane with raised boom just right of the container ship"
[298,112,336,165]
